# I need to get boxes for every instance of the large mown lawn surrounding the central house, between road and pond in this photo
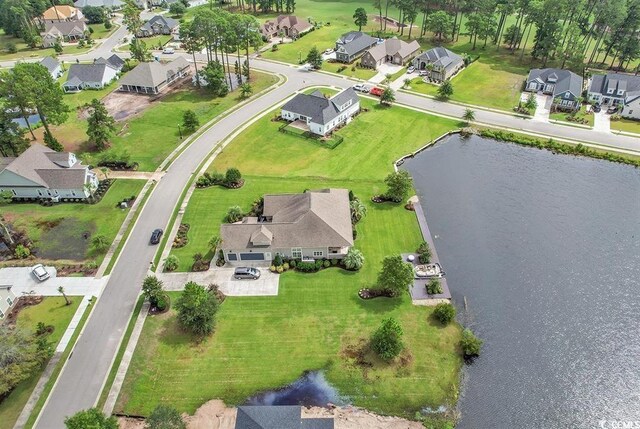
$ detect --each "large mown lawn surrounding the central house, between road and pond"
[116,94,461,417]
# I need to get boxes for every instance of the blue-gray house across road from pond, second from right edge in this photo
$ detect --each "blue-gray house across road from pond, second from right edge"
[525,68,582,110]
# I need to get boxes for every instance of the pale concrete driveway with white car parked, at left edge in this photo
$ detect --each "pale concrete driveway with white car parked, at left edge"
[0,267,108,296]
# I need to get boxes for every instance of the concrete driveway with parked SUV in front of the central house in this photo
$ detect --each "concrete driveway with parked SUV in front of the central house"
[158,267,280,296]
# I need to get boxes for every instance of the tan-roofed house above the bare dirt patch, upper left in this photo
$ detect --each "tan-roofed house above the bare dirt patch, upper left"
[120,57,191,94]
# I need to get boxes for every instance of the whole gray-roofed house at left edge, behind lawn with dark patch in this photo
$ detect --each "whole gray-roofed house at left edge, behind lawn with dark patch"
[0,143,98,199]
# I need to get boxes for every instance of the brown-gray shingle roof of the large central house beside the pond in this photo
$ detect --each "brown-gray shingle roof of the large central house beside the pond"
[220,189,353,249]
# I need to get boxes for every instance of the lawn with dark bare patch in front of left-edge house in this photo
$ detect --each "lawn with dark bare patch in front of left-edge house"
[2,179,144,264]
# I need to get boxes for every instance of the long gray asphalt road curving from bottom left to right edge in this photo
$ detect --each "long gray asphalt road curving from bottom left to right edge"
[28,55,640,429]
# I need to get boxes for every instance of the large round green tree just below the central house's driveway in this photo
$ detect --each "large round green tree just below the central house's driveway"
[175,282,219,336]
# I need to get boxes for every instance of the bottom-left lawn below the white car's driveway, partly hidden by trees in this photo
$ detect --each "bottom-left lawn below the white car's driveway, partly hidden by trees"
[0,297,82,429]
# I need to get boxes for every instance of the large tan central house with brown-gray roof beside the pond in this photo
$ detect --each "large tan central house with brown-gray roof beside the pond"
[220,189,353,262]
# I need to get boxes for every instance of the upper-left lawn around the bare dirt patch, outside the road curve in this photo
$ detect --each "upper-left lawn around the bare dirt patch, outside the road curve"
[36,71,277,171]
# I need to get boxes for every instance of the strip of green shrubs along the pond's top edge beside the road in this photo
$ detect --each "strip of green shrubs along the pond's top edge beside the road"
[480,129,640,167]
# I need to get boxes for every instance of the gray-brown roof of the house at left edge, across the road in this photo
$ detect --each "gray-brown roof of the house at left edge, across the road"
[0,144,86,189]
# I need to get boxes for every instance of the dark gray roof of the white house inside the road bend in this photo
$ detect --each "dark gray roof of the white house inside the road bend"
[282,88,359,125]
